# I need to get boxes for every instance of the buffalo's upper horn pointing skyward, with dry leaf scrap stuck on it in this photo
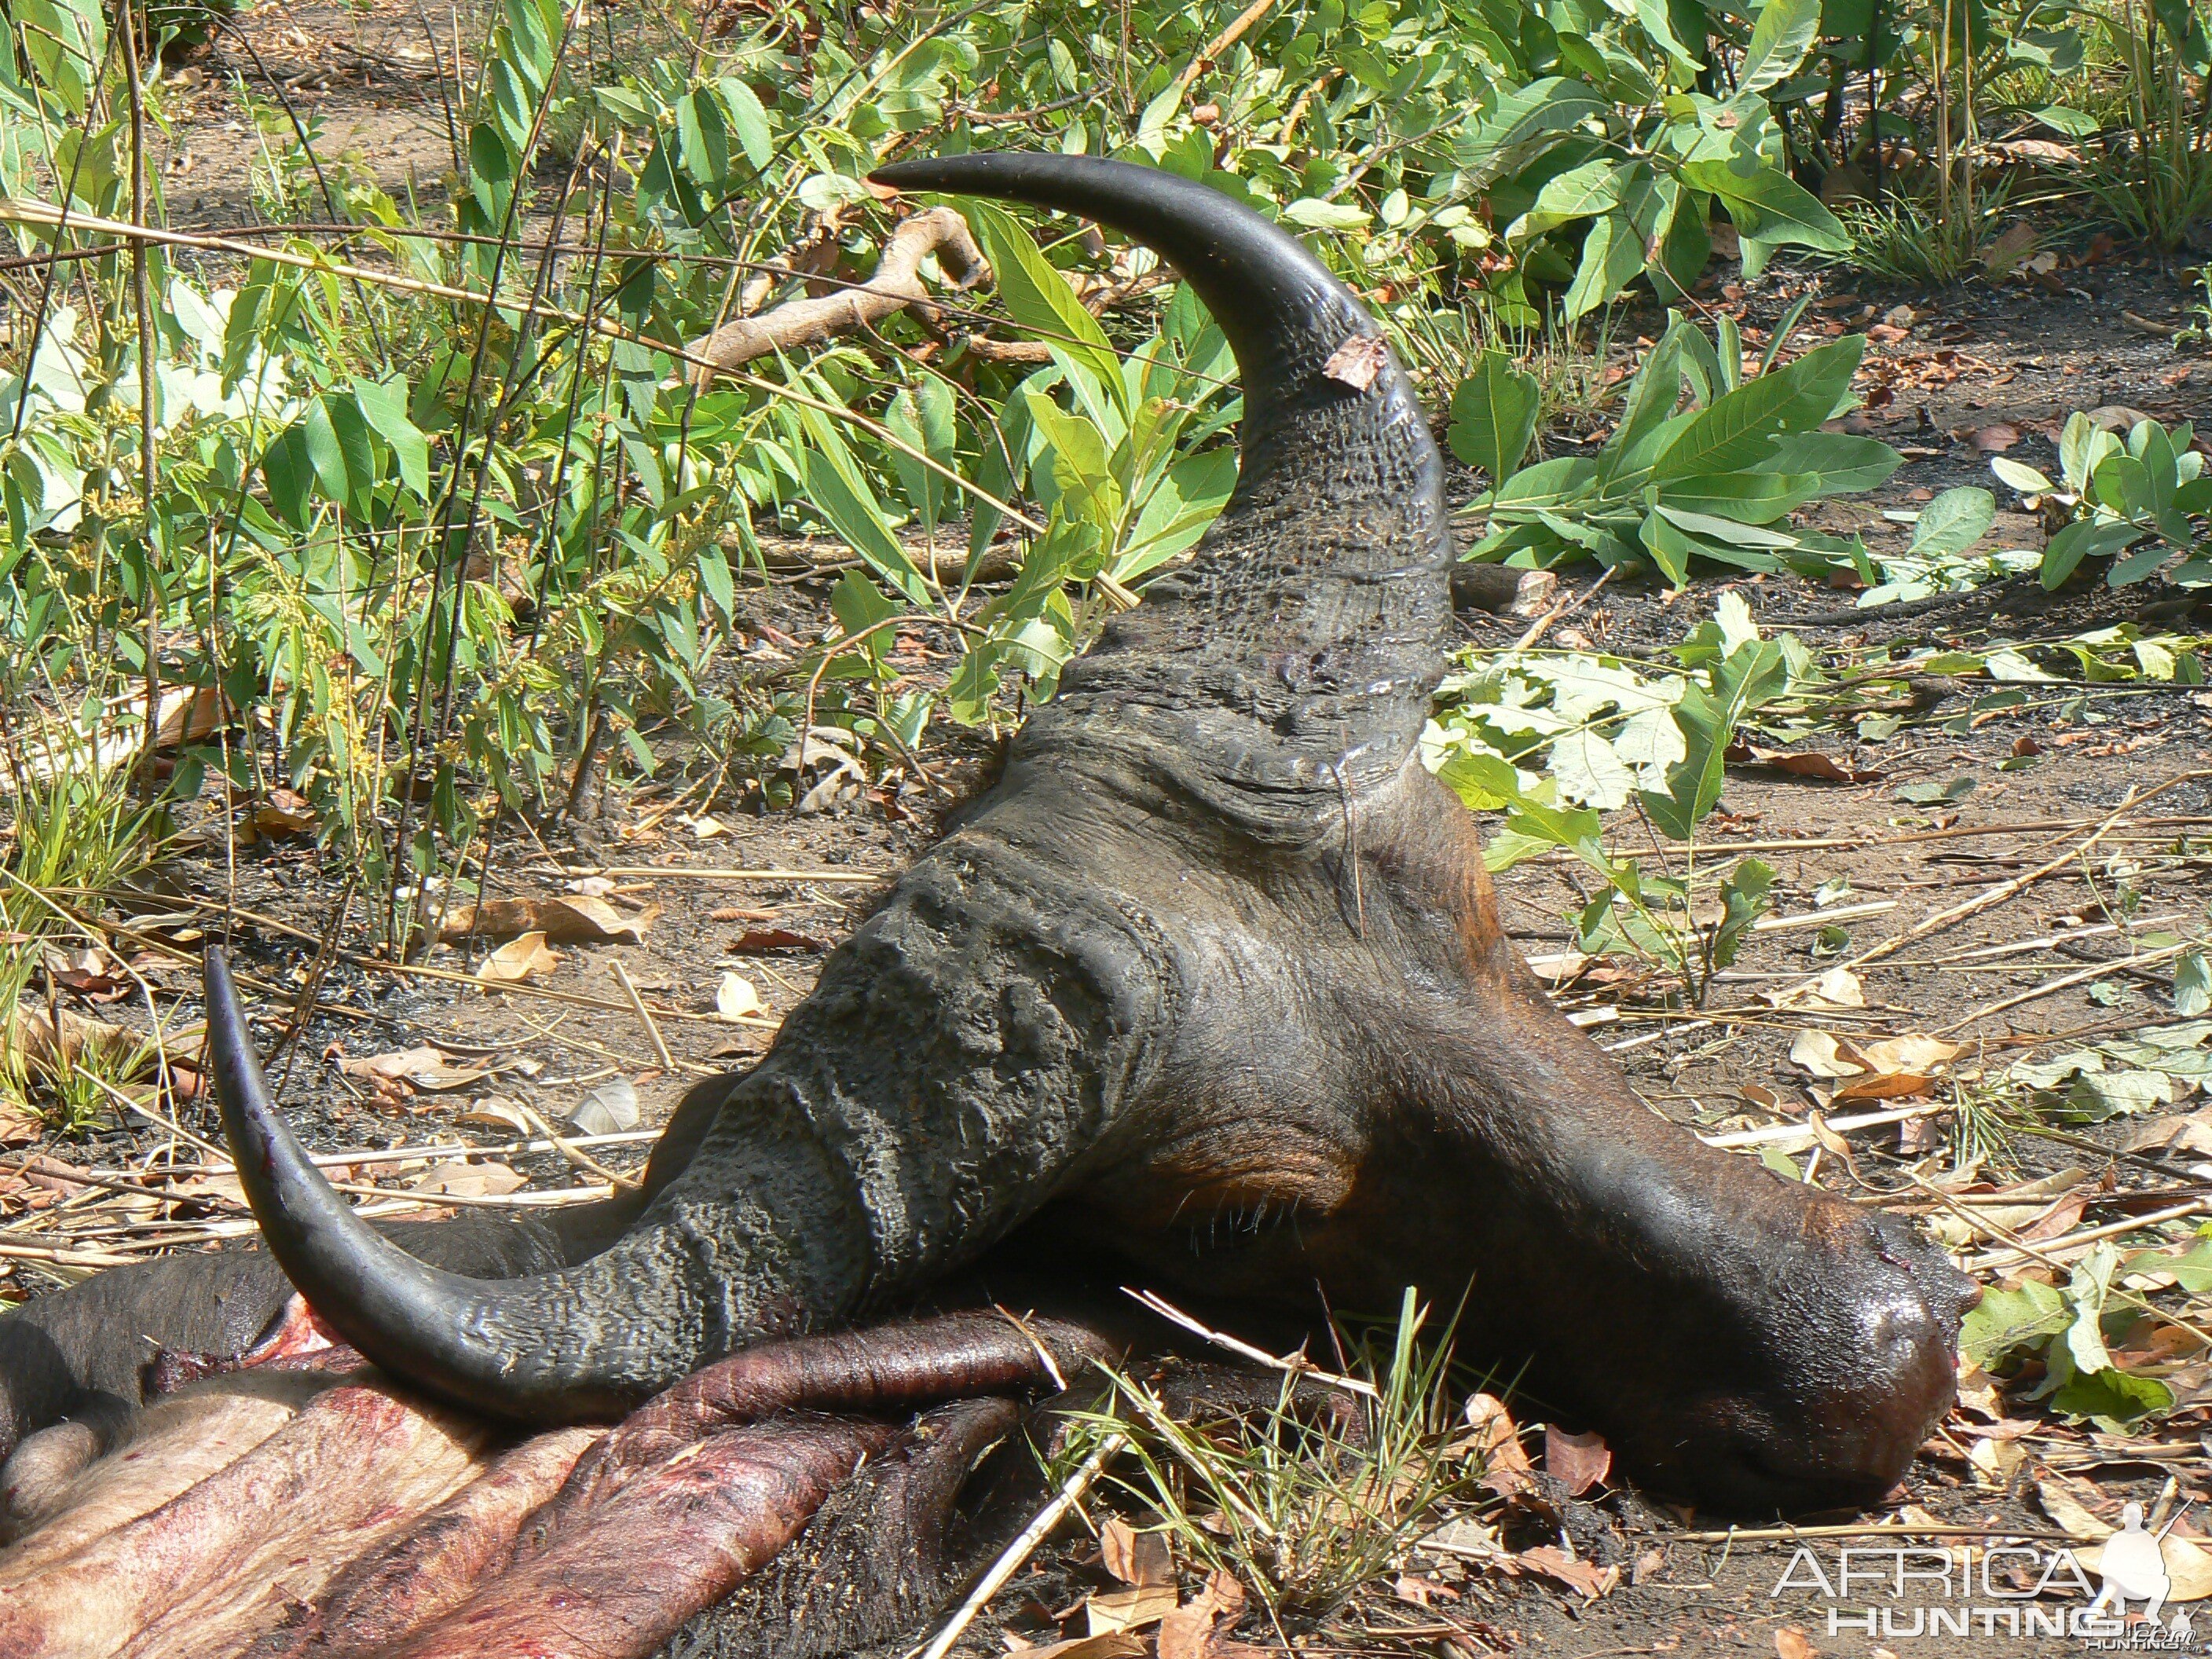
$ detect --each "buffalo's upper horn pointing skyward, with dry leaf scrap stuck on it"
[872,155,1453,840]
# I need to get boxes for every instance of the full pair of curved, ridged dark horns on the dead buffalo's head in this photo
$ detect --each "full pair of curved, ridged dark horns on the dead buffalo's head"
[206,155,1451,1423]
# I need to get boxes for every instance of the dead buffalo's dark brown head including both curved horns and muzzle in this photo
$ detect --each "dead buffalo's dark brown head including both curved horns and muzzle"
[0,145,1973,1659]
